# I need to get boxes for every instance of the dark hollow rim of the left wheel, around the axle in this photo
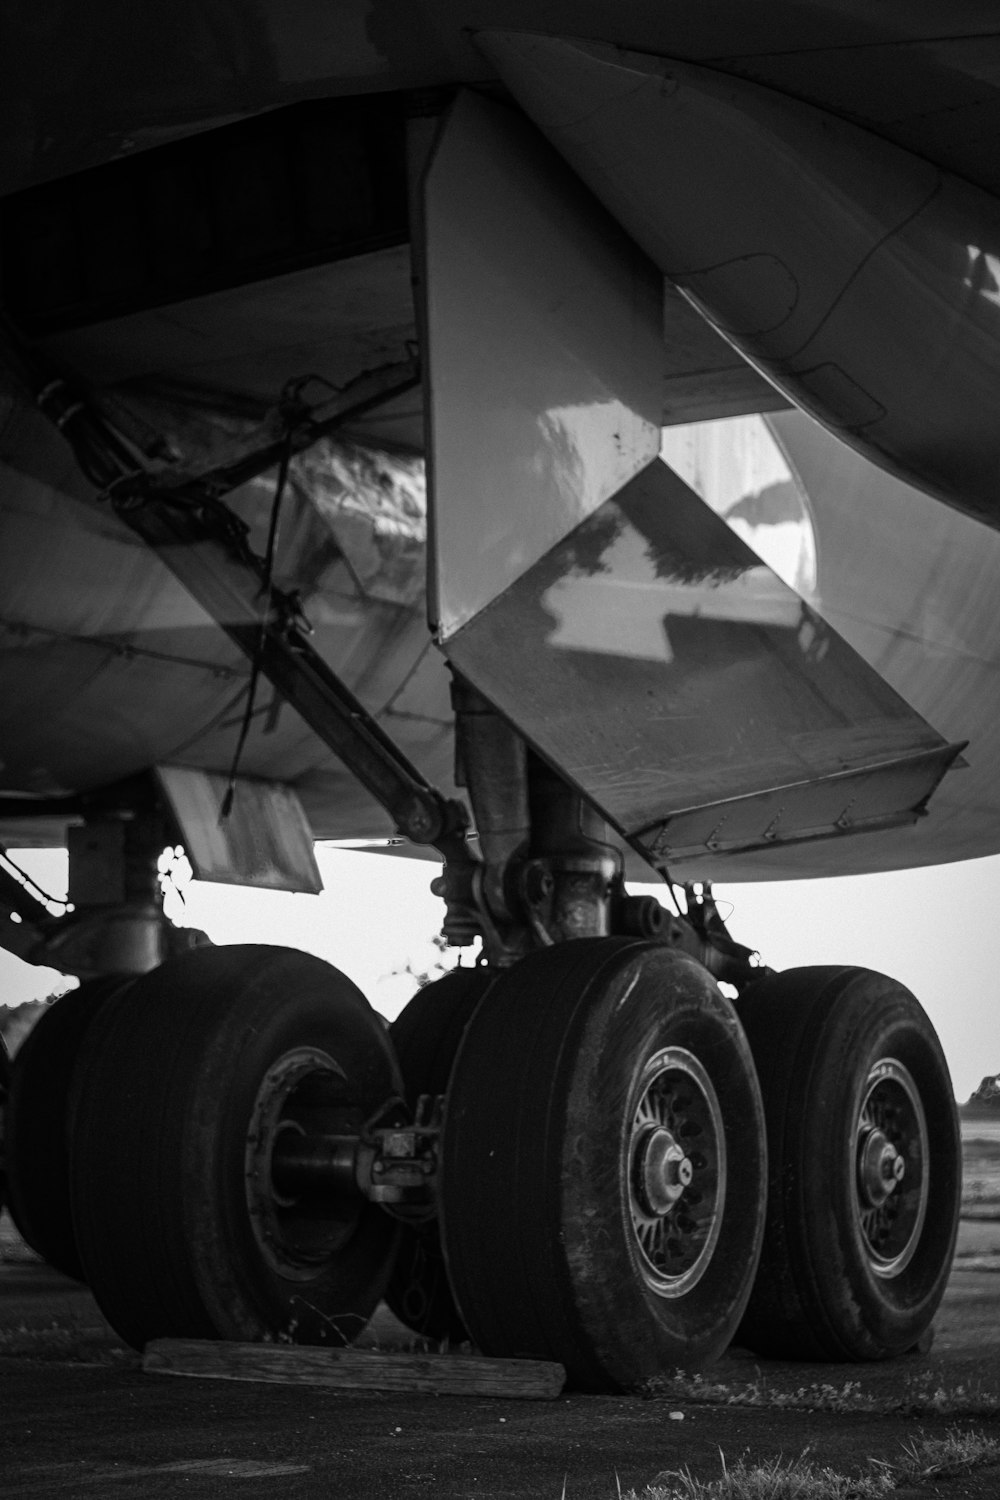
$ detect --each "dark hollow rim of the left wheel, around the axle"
[246,1047,363,1281]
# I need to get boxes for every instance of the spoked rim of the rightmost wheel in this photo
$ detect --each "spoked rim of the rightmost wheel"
[855,1058,930,1280]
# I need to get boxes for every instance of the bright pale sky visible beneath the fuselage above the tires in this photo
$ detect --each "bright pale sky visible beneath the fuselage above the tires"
[0,846,1000,1101]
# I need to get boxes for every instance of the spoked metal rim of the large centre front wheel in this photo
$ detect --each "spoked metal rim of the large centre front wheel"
[628,1047,726,1298]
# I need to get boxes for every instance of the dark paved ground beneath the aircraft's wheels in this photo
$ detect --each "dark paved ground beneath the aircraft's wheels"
[0,1224,1000,1500]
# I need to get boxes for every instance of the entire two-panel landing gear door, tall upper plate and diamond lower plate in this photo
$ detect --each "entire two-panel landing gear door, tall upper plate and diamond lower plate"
[423,95,958,879]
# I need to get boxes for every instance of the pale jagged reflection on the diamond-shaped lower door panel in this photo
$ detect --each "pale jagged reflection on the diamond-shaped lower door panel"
[543,524,802,662]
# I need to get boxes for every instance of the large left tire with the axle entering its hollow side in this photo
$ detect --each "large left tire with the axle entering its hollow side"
[72,945,402,1349]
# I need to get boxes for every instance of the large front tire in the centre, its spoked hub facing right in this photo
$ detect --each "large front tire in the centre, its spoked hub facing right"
[441,939,766,1391]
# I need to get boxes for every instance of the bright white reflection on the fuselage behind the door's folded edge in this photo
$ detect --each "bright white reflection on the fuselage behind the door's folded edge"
[660,417,816,599]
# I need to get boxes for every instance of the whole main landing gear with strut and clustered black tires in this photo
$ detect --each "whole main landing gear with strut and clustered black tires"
[6,717,960,1391]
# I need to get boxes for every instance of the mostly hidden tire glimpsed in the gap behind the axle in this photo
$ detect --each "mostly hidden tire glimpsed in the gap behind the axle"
[385,969,495,1344]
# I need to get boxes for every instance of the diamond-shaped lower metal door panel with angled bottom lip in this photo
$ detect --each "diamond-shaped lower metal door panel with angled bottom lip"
[445,462,951,867]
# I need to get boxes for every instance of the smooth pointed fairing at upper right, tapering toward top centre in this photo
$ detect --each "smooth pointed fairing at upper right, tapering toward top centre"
[481,33,1000,525]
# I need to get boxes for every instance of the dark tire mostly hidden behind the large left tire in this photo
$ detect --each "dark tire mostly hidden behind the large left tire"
[6,975,132,1281]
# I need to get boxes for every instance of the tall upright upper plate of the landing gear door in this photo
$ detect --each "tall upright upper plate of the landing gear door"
[424,95,663,638]
